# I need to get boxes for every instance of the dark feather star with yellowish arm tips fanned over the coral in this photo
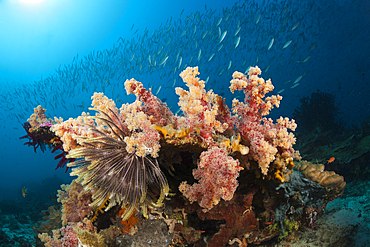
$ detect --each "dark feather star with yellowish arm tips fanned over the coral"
[67,106,169,220]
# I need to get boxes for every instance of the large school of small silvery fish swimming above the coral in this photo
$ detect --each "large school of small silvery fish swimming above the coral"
[0,0,342,139]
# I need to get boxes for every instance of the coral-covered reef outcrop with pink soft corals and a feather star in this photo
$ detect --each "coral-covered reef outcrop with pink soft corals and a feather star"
[18,67,345,247]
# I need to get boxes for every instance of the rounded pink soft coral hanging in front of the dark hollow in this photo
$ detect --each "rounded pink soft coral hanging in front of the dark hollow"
[179,146,243,212]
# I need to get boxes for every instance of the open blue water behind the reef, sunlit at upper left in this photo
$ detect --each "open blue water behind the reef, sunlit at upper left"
[0,0,370,245]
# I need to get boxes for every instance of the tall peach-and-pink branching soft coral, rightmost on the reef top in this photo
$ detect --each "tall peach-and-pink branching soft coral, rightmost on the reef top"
[230,67,299,175]
